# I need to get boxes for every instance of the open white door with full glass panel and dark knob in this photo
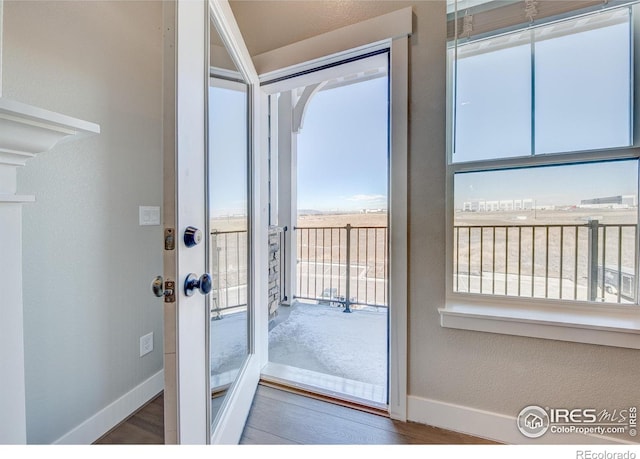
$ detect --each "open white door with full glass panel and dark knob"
[163,0,266,444]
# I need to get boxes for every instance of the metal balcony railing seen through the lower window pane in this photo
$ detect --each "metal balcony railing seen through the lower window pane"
[453,220,638,303]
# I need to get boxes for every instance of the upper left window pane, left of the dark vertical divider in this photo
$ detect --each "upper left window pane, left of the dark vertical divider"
[452,35,531,162]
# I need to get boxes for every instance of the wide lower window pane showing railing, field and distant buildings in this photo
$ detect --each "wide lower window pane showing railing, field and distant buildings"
[453,160,638,303]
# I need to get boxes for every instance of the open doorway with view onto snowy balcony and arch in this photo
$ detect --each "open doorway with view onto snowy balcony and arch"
[263,49,390,409]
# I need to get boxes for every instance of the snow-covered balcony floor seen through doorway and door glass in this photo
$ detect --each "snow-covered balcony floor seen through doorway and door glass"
[211,302,387,387]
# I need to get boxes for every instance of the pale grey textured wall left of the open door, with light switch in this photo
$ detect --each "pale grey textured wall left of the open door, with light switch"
[3,1,163,443]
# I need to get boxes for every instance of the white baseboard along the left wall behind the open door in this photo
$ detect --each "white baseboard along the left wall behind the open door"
[53,370,164,445]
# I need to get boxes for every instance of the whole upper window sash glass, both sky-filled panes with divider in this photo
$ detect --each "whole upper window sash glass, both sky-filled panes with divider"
[449,8,633,162]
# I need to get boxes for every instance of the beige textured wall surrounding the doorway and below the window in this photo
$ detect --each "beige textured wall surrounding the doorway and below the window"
[231,1,640,434]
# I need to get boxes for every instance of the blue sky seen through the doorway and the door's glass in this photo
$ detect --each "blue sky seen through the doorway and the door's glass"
[209,72,388,218]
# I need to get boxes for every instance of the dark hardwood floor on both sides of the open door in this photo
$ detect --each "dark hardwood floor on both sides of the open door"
[95,385,495,445]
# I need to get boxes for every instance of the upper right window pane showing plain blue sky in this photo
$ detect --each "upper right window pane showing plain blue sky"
[534,8,631,153]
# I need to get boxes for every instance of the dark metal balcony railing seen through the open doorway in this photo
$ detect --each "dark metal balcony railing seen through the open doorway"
[294,225,388,312]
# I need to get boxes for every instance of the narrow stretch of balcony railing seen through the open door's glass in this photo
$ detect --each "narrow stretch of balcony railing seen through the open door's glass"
[209,230,248,318]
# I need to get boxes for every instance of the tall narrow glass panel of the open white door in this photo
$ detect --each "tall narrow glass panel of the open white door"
[208,18,249,428]
